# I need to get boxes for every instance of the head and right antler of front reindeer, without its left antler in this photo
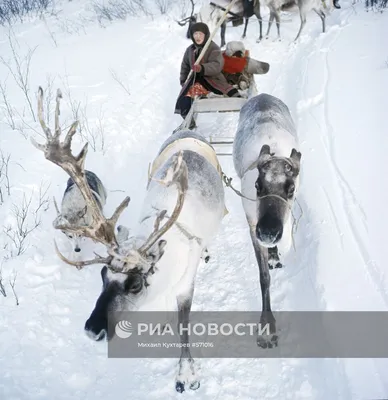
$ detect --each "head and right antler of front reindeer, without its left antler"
[85,153,187,340]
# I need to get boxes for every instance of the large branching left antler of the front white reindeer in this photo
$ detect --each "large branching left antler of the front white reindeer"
[31,87,130,266]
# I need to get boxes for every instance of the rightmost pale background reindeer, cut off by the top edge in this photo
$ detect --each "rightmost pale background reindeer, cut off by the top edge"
[261,0,327,42]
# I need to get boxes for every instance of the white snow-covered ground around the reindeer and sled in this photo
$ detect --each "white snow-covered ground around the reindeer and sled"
[0,0,388,400]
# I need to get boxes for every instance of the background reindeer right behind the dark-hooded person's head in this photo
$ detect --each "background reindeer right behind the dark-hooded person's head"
[178,0,263,47]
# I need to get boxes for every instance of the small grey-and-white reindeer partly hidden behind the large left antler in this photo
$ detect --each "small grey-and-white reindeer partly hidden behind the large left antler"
[53,171,108,253]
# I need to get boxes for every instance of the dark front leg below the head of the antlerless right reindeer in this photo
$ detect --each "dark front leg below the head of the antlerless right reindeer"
[250,227,278,348]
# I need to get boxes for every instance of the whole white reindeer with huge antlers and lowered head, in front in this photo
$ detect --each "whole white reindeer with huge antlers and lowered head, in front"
[32,88,225,392]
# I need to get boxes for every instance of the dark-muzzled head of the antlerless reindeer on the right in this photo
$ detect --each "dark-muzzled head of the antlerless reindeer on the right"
[255,145,301,247]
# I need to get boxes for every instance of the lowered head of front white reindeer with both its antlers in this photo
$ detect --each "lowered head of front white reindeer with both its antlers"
[32,88,188,340]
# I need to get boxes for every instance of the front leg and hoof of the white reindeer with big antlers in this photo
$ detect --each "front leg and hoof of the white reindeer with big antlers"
[175,241,202,393]
